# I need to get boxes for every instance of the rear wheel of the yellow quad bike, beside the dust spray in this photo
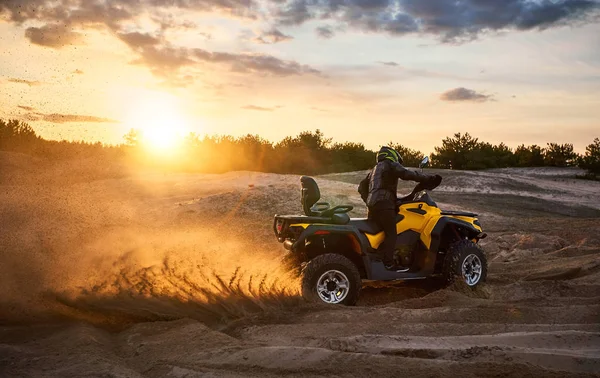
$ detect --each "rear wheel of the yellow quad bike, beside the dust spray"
[302,253,362,306]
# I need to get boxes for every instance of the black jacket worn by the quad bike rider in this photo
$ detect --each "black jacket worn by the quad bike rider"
[359,160,432,209]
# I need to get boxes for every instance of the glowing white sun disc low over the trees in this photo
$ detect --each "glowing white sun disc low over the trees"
[127,92,188,153]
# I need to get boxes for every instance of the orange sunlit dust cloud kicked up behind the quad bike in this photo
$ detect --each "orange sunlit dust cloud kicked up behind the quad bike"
[0,154,298,325]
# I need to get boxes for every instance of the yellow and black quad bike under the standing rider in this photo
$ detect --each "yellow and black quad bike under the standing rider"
[273,158,487,305]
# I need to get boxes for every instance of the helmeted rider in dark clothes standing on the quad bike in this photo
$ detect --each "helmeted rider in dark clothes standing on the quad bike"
[358,146,436,270]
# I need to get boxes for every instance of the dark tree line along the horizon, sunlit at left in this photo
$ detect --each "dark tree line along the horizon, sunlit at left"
[0,119,600,177]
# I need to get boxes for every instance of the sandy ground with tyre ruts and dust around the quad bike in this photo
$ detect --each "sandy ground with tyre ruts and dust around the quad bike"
[0,155,600,377]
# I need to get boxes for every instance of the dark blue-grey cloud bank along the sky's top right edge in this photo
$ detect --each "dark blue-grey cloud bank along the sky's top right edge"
[274,0,600,43]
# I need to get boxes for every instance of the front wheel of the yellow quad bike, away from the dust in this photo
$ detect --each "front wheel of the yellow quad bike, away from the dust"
[442,240,487,288]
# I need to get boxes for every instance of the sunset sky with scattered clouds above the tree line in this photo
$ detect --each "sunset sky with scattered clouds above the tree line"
[0,0,600,153]
